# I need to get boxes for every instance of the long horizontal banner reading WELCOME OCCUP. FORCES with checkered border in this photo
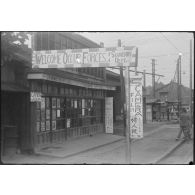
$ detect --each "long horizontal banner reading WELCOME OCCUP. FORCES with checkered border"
[32,46,137,68]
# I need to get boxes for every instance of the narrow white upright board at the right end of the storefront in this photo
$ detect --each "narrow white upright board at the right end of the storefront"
[105,97,113,133]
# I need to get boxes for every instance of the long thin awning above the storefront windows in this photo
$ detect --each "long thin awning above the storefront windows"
[27,73,116,90]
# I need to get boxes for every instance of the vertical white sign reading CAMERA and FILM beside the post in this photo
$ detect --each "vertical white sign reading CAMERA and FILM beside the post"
[130,77,143,139]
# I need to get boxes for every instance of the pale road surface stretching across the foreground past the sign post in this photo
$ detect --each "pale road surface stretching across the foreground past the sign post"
[1,124,193,164]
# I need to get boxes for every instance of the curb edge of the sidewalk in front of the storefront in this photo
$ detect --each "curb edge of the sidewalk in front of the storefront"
[35,138,124,159]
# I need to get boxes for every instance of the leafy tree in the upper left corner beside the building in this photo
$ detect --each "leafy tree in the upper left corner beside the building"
[1,32,31,65]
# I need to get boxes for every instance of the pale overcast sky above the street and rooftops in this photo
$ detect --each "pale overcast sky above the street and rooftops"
[79,32,194,87]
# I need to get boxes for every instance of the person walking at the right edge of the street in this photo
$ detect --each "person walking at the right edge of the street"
[176,108,191,140]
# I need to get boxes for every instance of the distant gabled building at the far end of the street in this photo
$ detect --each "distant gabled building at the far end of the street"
[146,81,193,121]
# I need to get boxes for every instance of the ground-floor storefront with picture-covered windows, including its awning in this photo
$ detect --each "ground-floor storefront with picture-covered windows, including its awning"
[28,72,115,149]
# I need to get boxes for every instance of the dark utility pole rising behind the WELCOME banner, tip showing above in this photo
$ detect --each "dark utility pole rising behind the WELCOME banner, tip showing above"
[118,39,126,136]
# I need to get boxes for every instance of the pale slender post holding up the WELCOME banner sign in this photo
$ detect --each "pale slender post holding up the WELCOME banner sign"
[125,67,131,164]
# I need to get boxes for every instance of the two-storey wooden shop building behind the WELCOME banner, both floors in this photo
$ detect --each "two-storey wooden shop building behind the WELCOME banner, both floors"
[27,32,116,150]
